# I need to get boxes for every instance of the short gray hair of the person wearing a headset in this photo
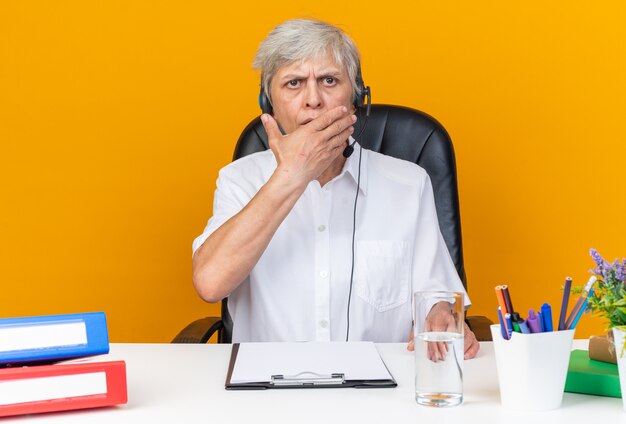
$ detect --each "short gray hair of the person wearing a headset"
[252,19,361,106]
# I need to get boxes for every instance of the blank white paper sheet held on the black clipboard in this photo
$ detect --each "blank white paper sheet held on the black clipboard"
[230,342,393,384]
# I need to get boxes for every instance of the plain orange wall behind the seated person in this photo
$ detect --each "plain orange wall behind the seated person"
[0,0,626,342]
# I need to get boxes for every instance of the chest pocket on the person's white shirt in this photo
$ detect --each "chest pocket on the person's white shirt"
[355,240,411,312]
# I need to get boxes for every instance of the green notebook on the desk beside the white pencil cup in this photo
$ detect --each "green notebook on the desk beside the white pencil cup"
[565,350,622,398]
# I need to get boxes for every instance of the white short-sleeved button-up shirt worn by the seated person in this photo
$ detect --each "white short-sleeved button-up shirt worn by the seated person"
[193,144,469,342]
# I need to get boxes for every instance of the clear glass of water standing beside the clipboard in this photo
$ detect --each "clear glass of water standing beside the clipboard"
[413,291,464,407]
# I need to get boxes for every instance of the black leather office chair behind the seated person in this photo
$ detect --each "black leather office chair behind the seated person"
[172,105,492,343]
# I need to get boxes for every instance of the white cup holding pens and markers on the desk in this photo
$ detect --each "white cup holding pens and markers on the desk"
[491,324,574,411]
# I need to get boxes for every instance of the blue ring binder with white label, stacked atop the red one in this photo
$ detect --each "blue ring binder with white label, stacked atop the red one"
[0,312,109,366]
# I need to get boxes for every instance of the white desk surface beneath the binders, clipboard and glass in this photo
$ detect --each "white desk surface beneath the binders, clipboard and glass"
[0,340,626,424]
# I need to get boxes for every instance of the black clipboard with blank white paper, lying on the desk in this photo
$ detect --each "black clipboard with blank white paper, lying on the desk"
[225,342,398,390]
